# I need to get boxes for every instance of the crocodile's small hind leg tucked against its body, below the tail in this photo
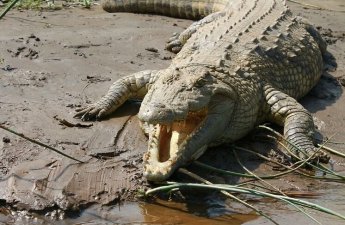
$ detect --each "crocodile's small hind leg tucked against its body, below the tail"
[166,11,225,53]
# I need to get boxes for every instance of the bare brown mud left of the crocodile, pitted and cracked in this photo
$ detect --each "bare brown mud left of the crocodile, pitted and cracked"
[0,4,190,210]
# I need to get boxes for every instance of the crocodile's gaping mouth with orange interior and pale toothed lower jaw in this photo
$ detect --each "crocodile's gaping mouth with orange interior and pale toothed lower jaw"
[144,110,207,181]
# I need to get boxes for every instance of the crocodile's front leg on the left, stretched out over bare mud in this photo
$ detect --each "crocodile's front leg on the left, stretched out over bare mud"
[74,70,158,120]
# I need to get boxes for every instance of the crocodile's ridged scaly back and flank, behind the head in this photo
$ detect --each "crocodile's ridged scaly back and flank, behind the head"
[172,0,324,98]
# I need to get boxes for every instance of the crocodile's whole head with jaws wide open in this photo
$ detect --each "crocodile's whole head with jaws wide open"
[138,69,234,181]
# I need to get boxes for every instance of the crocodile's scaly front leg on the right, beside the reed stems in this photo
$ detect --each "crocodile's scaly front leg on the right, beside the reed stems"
[265,87,329,162]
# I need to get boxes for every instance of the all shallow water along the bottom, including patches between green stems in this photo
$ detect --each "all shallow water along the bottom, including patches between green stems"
[0,183,345,225]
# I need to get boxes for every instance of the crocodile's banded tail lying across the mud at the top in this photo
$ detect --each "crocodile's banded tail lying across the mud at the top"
[102,0,230,19]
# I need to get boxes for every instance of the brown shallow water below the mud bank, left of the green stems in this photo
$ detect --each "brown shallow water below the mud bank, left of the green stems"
[0,201,258,225]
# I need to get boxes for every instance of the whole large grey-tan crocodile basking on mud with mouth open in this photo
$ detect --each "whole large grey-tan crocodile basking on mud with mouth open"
[75,0,329,181]
